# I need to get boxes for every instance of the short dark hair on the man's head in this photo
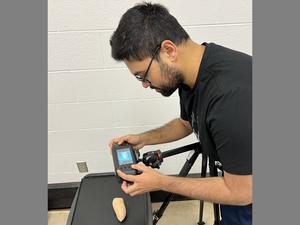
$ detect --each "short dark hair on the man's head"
[110,2,189,60]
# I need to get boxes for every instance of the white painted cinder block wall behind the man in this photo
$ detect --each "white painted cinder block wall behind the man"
[48,0,252,183]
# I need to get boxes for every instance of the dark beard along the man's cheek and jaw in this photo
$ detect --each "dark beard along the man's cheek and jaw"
[150,61,183,97]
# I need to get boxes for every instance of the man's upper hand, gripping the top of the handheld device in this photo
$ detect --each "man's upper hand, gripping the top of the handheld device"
[108,134,145,152]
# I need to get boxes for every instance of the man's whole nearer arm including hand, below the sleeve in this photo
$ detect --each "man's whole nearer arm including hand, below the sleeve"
[118,164,252,205]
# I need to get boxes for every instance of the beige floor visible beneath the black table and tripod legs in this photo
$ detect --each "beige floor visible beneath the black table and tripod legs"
[48,201,214,225]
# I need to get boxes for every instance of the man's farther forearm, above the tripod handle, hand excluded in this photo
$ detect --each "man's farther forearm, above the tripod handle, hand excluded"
[141,118,192,145]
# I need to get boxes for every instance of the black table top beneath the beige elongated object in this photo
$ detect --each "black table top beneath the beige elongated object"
[69,173,152,225]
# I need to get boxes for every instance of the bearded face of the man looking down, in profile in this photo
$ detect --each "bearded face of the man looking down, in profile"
[124,58,183,97]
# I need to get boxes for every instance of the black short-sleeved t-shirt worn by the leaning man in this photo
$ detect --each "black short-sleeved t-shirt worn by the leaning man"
[179,43,252,175]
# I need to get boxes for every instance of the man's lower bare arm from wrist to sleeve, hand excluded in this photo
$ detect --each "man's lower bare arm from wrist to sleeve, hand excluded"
[160,172,252,205]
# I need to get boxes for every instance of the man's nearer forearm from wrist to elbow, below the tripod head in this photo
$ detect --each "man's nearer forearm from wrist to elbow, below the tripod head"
[159,176,251,205]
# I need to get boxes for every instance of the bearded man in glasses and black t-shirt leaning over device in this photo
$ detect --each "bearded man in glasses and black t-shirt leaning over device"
[109,3,252,225]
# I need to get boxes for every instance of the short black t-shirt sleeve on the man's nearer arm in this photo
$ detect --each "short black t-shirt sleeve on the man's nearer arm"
[206,87,252,175]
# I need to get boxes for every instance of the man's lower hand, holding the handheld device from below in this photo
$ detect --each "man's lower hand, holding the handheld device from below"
[117,164,164,196]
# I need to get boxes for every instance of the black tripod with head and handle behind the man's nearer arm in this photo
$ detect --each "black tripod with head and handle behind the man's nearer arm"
[139,143,220,225]
